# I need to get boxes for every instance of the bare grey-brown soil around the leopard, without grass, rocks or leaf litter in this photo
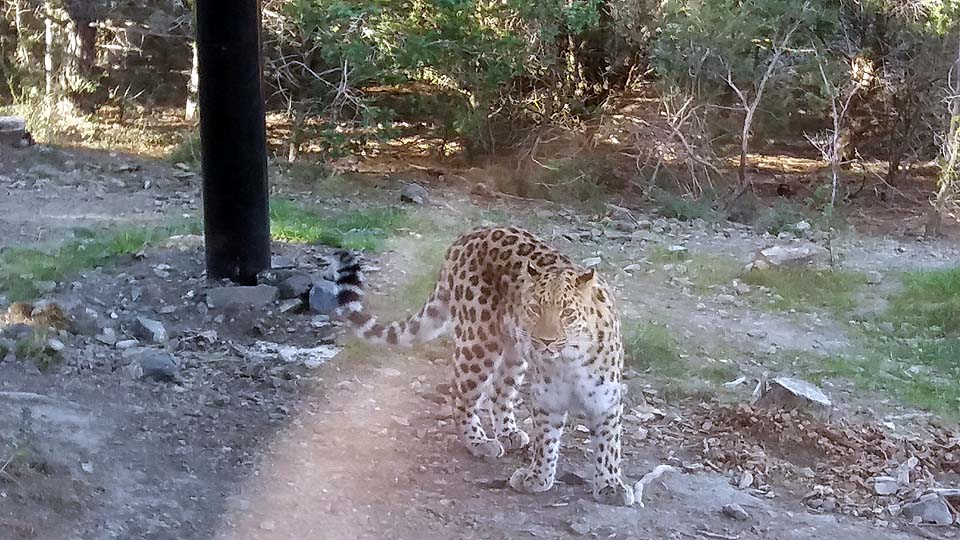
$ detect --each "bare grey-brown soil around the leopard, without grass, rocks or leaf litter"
[0,143,960,540]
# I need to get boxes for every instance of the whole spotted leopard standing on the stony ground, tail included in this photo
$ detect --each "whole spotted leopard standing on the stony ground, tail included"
[332,227,634,506]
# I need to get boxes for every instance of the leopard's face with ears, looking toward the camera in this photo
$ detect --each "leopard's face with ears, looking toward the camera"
[520,265,596,357]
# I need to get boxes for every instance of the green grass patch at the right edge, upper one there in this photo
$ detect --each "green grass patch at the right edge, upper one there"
[886,268,960,337]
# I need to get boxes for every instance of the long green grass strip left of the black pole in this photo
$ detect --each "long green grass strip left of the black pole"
[0,223,200,302]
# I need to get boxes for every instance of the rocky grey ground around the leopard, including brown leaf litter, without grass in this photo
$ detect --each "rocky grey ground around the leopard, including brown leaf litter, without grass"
[0,143,960,540]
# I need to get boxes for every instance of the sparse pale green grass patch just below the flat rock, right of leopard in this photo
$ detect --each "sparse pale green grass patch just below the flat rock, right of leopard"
[742,268,866,314]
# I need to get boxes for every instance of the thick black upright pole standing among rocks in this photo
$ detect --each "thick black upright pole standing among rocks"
[196,0,270,285]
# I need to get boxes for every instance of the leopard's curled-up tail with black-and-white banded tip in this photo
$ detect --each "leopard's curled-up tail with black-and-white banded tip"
[334,251,451,346]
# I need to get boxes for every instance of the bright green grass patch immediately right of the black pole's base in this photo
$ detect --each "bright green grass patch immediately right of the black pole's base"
[270,200,408,251]
